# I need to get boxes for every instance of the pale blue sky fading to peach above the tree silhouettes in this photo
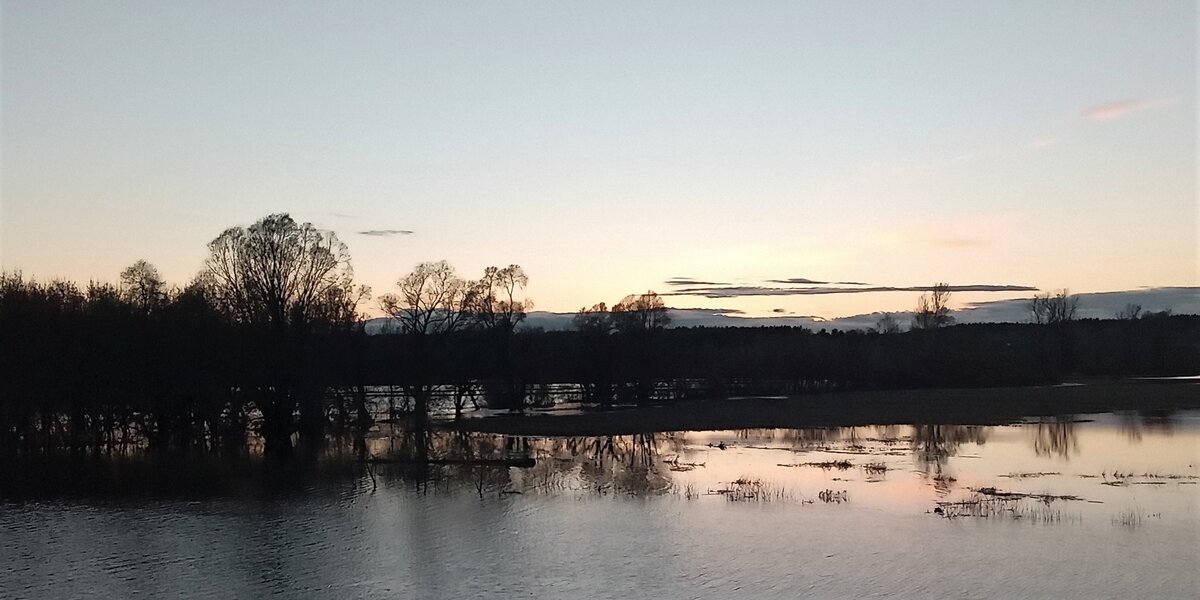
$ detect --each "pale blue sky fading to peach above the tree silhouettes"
[0,0,1200,318]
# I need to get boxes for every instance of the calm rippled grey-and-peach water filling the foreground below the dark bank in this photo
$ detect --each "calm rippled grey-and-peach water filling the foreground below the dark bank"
[0,412,1200,599]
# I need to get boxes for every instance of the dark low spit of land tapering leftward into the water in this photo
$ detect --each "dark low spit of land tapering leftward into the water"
[448,379,1200,437]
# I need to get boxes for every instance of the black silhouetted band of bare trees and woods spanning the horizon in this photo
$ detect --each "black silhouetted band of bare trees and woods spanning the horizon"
[0,215,1200,457]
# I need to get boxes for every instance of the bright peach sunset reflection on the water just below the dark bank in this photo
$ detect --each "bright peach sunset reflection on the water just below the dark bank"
[355,412,1200,524]
